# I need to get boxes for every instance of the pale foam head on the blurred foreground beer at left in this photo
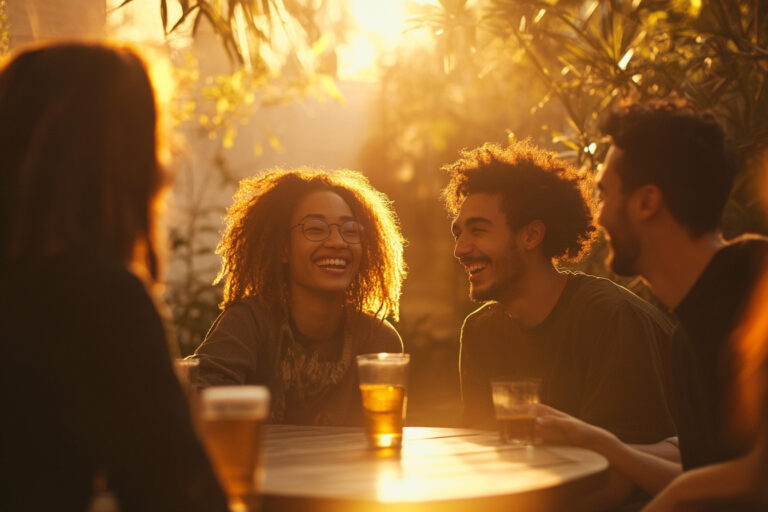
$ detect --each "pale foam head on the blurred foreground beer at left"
[201,386,269,419]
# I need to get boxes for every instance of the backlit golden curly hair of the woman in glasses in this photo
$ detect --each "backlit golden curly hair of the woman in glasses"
[215,168,406,320]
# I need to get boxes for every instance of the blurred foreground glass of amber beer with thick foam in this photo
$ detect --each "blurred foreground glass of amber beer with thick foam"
[200,386,269,512]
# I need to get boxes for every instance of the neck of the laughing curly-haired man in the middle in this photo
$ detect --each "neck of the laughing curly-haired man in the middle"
[501,261,568,327]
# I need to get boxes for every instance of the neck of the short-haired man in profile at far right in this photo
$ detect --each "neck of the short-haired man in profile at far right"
[638,230,725,309]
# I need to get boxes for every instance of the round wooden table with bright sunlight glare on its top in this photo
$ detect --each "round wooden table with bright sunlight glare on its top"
[263,425,608,512]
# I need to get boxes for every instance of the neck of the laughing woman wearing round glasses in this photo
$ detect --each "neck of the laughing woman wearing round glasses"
[290,283,345,341]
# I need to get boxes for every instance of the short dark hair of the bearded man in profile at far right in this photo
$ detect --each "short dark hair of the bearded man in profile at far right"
[602,101,738,236]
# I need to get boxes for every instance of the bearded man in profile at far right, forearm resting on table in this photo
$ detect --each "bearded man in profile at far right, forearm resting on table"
[540,103,768,510]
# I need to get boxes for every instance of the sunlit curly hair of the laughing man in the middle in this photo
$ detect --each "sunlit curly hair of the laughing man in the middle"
[443,140,597,261]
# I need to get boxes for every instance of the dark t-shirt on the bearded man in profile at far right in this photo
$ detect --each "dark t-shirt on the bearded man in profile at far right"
[668,237,768,470]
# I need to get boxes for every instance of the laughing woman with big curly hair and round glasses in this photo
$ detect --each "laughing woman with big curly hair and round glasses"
[196,168,405,425]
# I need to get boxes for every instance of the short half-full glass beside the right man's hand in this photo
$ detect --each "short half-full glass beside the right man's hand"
[491,379,541,446]
